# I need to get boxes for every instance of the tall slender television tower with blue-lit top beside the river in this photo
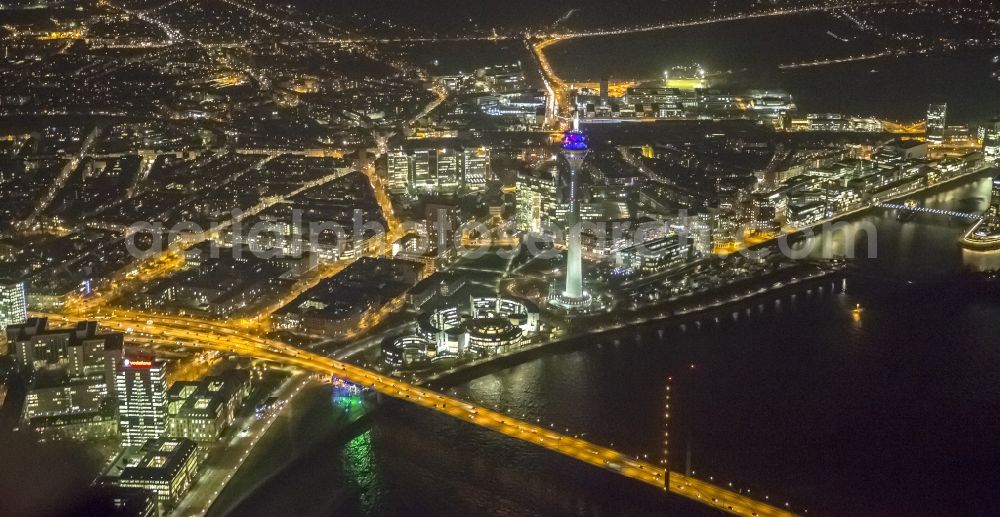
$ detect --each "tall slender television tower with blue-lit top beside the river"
[549,114,591,310]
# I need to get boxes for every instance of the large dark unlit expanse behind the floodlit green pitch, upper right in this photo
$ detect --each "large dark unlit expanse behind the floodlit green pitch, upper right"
[546,14,1000,124]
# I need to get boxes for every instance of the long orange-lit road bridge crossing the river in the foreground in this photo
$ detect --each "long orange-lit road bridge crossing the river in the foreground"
[33,310,793,517]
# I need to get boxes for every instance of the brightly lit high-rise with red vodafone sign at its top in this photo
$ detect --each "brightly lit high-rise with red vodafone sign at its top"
[115,357,167,446]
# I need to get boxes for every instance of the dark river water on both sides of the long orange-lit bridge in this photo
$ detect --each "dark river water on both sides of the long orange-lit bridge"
[215,172,1000,517]
